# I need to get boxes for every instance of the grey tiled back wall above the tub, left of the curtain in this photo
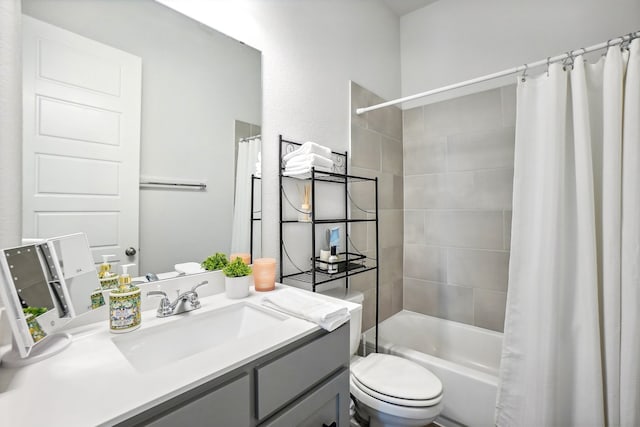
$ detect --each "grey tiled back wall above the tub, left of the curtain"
[403,86,515,331]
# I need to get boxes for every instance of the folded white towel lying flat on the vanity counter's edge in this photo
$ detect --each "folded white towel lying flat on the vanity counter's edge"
[262,288,351,331]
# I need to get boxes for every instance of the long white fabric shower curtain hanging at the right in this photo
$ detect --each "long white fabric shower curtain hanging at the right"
[496,39,640,427]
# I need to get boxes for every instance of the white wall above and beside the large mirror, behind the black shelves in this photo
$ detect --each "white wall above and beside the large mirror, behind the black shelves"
[159,0,400,256]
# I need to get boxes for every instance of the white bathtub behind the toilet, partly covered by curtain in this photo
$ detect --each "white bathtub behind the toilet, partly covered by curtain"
[365,310,502,427]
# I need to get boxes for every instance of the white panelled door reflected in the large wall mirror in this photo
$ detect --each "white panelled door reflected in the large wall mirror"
[22,16,142,274]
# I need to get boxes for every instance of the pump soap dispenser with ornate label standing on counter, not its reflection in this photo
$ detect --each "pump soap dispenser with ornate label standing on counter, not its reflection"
[109,264,141,334]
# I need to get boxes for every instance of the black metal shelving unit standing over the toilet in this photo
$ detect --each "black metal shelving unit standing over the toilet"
[278,135,380,349]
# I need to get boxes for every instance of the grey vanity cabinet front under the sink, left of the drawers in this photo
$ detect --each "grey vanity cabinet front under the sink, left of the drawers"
[145,374,251,427]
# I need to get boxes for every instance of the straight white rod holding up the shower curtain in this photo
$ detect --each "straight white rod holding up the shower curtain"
[356,31,640,115]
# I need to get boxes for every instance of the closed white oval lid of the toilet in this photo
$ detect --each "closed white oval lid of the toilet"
[351,353,442,404]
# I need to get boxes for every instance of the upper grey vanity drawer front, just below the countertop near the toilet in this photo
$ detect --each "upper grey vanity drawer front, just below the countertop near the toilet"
[255,323,349,420]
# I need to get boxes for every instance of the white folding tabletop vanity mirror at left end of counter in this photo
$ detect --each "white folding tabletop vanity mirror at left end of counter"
[0,233,100,367]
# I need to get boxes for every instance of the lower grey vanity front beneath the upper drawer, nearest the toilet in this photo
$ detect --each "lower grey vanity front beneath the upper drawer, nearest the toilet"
[262,368,349,427]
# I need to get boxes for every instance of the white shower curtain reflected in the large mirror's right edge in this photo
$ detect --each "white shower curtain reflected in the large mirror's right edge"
[231,138,261,253]
